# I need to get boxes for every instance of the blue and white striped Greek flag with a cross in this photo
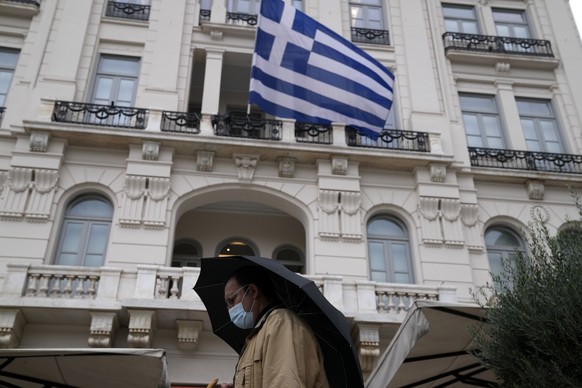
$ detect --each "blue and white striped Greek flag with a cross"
[249,0,394,139]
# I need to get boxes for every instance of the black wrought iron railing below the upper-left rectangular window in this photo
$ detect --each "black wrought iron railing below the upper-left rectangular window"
[52,101,149,129]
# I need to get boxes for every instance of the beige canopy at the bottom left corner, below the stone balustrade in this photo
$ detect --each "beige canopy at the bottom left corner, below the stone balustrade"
[0,349,170,388]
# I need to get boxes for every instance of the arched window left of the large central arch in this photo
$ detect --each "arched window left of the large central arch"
[55,194,113,267]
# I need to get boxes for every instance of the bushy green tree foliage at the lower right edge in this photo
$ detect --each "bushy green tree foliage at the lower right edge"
[474,192,582,387]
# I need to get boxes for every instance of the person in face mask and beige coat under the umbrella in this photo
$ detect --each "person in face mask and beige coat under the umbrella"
[222,266,329,388]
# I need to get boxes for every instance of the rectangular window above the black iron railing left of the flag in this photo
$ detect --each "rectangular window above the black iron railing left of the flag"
[91,55,140,106]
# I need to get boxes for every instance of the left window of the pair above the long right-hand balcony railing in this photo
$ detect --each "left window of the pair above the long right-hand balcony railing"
[460,94,505,149]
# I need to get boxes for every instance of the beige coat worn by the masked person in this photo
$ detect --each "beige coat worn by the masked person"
[234,308,329,388]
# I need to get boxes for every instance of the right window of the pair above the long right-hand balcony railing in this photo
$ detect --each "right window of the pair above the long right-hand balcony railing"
[516,98,564,154]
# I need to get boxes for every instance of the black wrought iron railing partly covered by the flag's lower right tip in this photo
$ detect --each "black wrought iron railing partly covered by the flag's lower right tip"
[346,127,430,152]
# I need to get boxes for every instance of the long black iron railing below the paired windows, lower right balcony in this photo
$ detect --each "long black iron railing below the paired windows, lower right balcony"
[469,147,582,174]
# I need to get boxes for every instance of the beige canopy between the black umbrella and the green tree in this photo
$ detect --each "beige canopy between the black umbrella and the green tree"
[366,301,497,388]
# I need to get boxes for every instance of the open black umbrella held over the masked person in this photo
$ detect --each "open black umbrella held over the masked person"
[194,256,364,388]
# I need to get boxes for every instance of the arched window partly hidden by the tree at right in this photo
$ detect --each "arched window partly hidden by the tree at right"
[485,226,524,275]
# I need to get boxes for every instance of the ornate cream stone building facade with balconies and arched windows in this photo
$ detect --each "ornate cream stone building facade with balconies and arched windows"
[0,0,582,386]
